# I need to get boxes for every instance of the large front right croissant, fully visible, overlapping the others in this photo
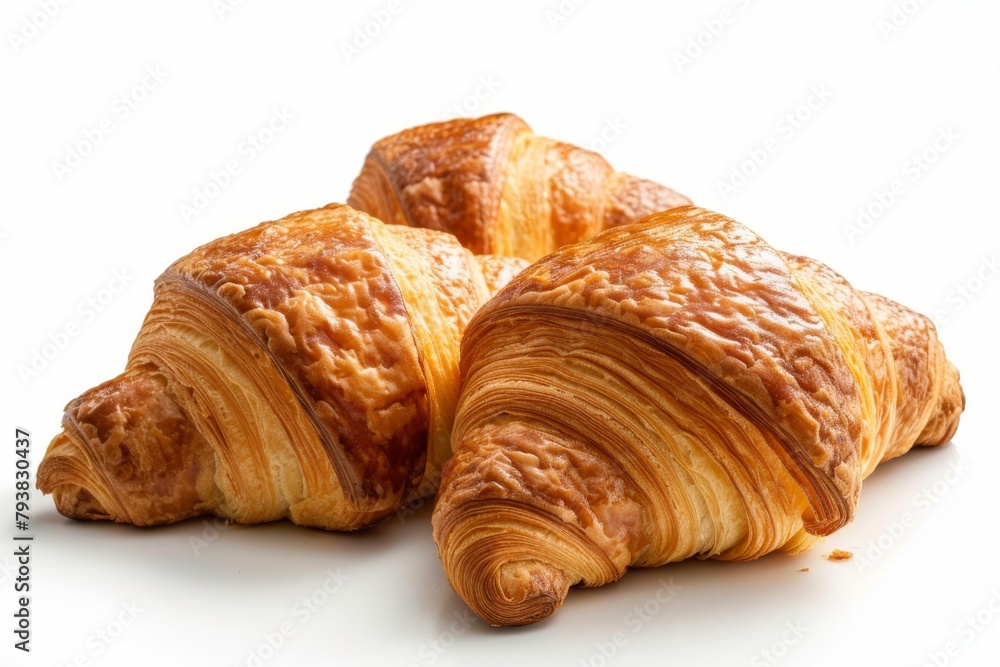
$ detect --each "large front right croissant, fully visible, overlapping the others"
[433,207,965,625]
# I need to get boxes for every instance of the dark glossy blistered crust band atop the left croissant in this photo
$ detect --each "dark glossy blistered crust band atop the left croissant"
[169,208,429,502]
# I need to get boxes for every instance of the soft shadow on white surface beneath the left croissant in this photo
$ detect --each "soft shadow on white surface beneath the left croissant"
[33,498,436,612]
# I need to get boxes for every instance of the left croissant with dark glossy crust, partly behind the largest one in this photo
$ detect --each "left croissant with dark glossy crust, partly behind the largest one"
[38,205,525,530]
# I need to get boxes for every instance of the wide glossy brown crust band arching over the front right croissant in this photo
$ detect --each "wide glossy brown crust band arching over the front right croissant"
[467,208,861,534]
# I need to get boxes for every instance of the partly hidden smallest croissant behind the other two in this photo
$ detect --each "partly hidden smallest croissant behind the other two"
[347,113,691,261]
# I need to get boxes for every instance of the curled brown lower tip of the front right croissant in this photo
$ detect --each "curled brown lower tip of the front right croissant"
[438,422,642,625]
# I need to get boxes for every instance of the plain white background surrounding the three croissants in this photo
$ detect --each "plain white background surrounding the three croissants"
[0,0,1000,666]
